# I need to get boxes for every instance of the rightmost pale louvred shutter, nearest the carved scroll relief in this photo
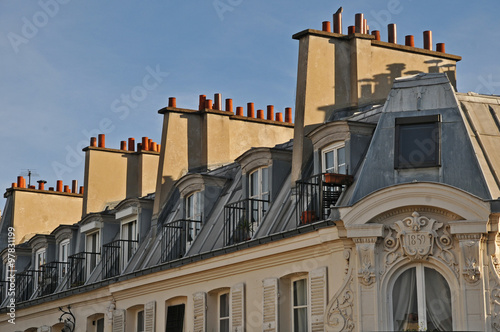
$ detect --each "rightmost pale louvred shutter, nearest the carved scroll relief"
[309,267,327,332]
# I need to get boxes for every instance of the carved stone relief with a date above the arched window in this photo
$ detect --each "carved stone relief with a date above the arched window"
[380,211,459,278]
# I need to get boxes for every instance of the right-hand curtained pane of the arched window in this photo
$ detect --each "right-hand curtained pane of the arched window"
[424,268,453,331]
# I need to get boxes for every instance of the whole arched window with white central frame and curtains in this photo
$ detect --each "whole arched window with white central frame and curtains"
[392,264,453,331]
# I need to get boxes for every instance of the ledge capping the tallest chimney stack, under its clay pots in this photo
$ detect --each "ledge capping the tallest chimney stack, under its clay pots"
[292,29,462,61]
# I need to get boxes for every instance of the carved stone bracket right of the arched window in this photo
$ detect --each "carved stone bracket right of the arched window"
[457,234,482,284]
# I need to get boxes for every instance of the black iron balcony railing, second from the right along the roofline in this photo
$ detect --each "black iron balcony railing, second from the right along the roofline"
[224,198,269,245]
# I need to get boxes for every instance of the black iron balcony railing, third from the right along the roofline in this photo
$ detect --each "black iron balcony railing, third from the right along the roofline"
[161,219,202,262]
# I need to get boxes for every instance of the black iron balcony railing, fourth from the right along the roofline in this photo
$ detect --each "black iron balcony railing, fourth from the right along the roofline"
[102,240,139,279]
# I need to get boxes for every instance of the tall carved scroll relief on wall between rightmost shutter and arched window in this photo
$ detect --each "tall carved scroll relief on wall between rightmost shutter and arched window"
[325,249,354,332]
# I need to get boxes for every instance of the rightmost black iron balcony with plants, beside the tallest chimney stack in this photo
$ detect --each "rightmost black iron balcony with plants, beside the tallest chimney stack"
[296,173,353,226]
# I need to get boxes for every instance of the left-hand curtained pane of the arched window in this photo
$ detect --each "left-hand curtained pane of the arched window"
[392,268,418,331]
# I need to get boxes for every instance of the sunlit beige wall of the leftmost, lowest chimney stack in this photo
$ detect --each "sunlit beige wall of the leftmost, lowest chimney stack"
[11,188,83,244]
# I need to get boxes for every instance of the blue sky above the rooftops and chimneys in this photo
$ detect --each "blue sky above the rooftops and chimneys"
[0,0,500,207]
